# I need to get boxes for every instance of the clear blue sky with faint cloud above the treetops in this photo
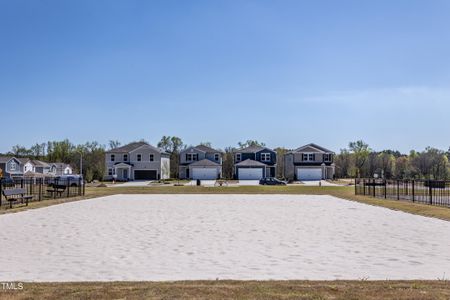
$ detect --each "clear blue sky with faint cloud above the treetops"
[0,0,450,152]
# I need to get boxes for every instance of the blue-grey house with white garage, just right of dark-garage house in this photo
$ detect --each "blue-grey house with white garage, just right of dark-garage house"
[179,145,223,180]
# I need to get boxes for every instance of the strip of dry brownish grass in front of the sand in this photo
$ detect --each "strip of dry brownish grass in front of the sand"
[0,280,450,300]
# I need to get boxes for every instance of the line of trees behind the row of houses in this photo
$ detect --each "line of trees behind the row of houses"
[6,136,450,181]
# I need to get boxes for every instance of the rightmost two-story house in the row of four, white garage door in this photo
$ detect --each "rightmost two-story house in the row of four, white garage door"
[284,144,335,181]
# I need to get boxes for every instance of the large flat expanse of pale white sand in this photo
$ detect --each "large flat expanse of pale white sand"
[0,195,450,281]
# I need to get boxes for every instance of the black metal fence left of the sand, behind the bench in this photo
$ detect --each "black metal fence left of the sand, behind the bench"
[0,177,85,207]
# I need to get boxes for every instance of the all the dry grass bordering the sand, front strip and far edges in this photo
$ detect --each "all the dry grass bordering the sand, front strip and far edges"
[0,185,450,299]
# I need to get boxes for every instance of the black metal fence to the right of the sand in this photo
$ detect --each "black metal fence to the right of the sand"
[355,179,450,207]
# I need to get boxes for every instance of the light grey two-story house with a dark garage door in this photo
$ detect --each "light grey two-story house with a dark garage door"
[105,142,170,181]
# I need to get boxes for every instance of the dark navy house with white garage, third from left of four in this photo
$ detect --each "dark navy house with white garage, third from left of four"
[234,146,277,180]
